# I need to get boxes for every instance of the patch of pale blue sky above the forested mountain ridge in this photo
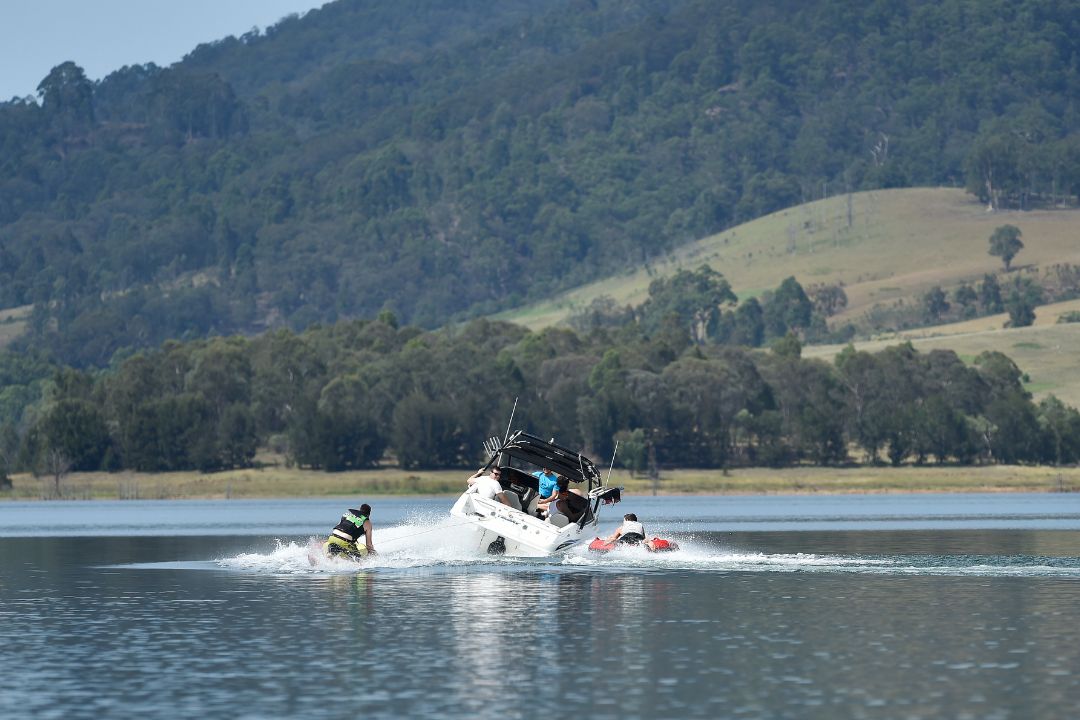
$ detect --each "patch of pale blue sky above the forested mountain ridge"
[0,0,328,100]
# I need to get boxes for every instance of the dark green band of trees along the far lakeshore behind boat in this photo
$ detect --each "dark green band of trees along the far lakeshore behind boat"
[0,269,1080,483]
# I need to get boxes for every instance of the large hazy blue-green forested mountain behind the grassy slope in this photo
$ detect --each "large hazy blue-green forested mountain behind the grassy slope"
[0,0,1080,366]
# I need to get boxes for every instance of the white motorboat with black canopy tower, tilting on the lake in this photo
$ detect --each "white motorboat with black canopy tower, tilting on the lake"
[450,431,621,557]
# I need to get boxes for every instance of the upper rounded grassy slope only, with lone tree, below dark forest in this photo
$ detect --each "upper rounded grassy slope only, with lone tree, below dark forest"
[500,188,1080,329]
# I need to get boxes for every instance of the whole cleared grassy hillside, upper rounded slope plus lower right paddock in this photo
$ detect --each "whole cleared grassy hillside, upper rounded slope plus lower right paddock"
[502,188,1080,407]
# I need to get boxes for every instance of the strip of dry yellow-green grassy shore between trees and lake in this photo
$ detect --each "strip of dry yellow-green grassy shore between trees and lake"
[0,465,1080,502]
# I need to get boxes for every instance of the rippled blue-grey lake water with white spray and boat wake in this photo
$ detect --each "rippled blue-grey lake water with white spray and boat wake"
[0,494,1080,720]
